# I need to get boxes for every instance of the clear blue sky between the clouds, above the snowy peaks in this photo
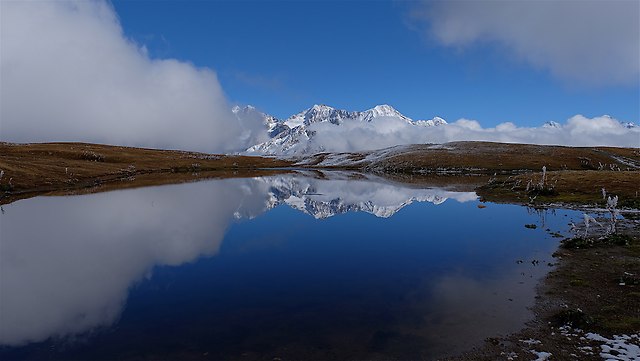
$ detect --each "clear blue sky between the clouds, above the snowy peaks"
[113,1,640,126]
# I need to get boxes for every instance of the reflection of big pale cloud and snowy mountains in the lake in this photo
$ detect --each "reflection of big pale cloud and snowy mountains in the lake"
[0,175,476,346]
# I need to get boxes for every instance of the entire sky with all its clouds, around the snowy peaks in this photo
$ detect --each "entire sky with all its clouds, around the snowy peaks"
[0,0,640,152]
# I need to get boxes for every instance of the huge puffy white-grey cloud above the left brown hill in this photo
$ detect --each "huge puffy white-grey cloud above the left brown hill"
[0,1,261,152]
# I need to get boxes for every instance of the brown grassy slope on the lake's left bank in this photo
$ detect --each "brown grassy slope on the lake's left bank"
[0,143,291,203]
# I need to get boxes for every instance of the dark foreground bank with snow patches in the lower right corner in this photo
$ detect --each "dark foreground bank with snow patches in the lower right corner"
[447,219,640,361]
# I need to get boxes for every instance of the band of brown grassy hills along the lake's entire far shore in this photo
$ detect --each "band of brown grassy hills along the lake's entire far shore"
[0,142,640,208]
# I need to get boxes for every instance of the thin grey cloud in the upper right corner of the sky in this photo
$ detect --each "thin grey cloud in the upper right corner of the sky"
[411,0,640,86]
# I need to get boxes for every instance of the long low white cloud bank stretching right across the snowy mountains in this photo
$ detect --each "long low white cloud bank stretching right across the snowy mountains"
[306,115,640,152]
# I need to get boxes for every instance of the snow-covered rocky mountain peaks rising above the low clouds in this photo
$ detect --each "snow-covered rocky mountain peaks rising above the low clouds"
[238,104,447,155]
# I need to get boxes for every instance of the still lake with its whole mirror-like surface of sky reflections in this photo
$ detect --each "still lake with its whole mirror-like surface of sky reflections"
[0,173,580,360]
